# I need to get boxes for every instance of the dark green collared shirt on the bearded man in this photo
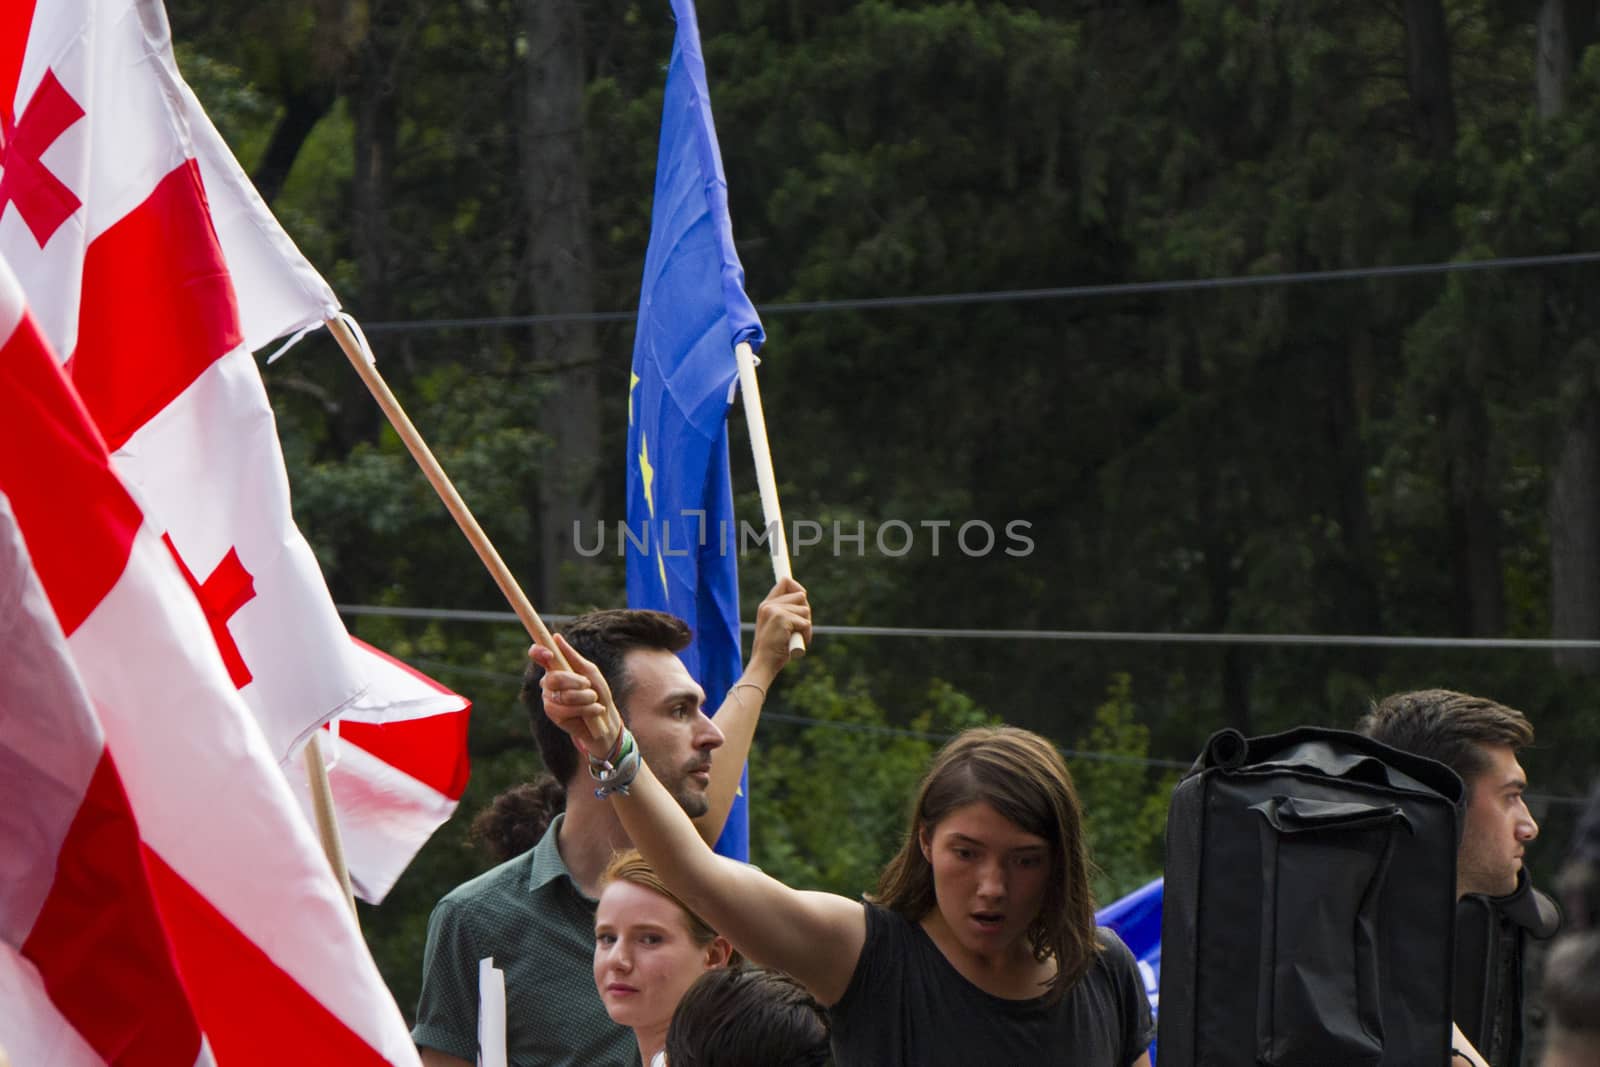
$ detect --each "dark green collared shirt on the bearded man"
[411,816,638,1067]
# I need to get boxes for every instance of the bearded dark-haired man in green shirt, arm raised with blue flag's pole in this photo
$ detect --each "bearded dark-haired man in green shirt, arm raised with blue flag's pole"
[411,579,811,1067]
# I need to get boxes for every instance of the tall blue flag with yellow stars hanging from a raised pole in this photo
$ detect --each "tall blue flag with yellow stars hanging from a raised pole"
[627,0,765,859]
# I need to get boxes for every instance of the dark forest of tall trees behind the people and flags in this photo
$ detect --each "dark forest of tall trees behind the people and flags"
[168,0,1600,1013]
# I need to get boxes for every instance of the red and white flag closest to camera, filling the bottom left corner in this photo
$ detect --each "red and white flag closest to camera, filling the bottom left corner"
[0,261,418,1067]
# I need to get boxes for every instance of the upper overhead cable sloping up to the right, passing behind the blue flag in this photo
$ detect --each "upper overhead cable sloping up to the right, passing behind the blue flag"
[362,251,1600,333]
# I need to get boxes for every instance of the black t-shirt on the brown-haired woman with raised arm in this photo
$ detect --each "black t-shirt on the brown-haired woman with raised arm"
[829,904,1155,1067]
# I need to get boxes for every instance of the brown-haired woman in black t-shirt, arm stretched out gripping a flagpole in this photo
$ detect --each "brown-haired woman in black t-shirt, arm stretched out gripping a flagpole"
[531,646,1152,1067]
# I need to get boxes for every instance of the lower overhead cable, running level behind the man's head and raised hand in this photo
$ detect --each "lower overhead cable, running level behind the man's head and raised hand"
[336,605,1600,651]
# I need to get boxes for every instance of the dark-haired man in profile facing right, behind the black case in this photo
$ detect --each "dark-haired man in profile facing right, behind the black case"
[1355,689,1560,1067]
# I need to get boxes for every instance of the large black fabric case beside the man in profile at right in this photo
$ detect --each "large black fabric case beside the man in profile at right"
[1157,726,1462,1067]
